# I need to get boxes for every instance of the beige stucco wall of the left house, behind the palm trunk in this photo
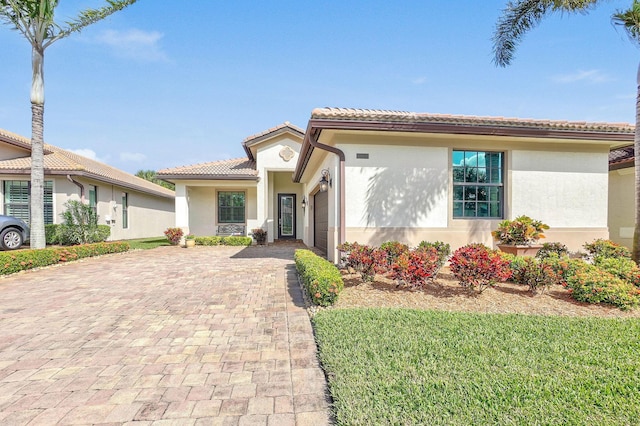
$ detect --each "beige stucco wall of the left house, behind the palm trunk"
[0,175,175,240]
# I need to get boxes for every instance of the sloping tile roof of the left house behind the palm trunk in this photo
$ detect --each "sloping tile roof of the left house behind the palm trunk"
[0,129,175,198]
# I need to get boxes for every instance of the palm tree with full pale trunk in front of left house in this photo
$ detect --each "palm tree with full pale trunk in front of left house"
[0,0,137,248]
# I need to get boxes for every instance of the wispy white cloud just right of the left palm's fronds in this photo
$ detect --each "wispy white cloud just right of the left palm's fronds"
[97,28,167,62]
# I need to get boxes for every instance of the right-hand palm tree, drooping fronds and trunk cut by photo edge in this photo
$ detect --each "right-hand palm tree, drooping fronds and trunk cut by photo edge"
[493,0,640,262]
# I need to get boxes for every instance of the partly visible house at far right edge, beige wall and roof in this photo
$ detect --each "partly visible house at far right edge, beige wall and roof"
[609,145,636,248]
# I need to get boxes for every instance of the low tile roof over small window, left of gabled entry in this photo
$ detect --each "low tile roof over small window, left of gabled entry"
[158,157,258,180]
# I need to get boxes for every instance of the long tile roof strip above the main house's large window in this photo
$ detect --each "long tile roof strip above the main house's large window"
[311,108,635,133]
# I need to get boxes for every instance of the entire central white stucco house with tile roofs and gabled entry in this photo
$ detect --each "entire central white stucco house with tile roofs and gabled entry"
[158,108,634,261]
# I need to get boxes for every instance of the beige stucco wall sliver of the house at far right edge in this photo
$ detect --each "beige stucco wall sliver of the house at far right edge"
[609,167,635,248]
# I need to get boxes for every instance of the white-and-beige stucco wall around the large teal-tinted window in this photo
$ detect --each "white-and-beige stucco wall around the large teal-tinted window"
[302,132,608,261]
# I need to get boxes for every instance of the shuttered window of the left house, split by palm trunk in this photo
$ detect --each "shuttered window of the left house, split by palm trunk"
[3,180,53,225]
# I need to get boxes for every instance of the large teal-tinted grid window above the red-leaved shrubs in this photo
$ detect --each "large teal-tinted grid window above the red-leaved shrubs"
[453,151,504,219]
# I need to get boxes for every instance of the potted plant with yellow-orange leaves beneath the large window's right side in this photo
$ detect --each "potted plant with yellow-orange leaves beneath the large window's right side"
[491,215,549,256]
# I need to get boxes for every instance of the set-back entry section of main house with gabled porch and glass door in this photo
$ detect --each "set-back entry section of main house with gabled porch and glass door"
[158,123,304,242]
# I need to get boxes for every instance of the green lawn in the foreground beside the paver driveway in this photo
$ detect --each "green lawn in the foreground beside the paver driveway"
[313,309,640,425]
